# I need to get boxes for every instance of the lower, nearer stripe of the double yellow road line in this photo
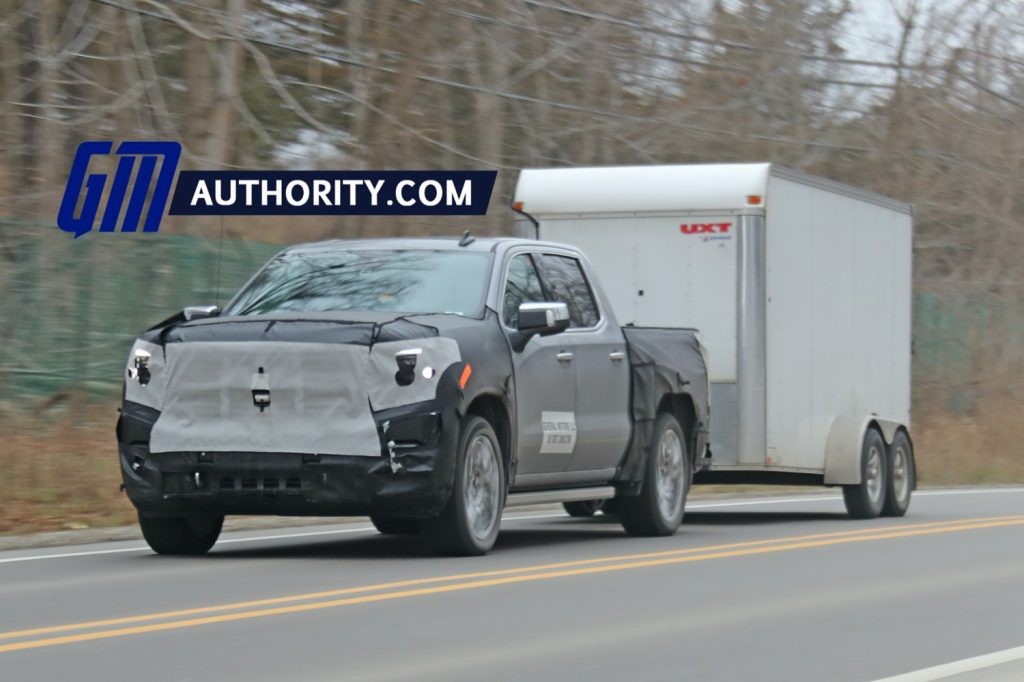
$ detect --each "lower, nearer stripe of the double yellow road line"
[0,517,1024,653]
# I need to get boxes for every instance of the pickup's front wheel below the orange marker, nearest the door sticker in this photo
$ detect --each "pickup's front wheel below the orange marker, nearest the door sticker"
[429,417,506,556]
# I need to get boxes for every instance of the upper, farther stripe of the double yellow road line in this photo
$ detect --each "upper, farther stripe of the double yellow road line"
[0,515,1024,640]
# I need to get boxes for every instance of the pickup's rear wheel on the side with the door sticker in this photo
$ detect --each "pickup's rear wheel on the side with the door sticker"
[615,414,693,536]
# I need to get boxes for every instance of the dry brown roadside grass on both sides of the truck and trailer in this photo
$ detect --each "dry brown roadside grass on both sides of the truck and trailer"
[0,397,1024,534]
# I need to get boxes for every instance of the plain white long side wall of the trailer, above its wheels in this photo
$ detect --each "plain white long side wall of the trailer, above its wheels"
[765,176,911,470]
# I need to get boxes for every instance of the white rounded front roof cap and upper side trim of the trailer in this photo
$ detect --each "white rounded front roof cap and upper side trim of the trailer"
[513,163,910,216]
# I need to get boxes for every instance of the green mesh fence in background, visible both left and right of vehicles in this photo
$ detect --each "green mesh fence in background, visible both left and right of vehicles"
[0,220,1024,411]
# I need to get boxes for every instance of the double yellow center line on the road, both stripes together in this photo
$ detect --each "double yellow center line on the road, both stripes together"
[0,516,1024,653]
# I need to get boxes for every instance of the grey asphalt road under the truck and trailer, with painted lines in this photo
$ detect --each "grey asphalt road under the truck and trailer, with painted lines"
[0,488,1024,682]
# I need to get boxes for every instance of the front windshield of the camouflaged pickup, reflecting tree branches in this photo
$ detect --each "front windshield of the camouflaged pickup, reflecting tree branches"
[224,250,490,316]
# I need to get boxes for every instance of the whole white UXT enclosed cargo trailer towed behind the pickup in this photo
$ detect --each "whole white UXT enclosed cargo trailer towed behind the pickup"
[514,164,915,517]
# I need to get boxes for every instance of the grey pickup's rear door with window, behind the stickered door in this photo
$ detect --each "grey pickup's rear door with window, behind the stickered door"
[536,253,631,473]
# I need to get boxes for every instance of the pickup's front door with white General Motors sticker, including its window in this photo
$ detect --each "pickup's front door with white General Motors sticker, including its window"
[501,252,577,475]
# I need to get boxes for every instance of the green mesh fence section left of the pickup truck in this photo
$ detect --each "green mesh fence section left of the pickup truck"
[0,220,282,400]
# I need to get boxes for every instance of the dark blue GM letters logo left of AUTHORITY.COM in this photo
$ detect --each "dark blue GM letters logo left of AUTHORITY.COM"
[57,141,181,239]
